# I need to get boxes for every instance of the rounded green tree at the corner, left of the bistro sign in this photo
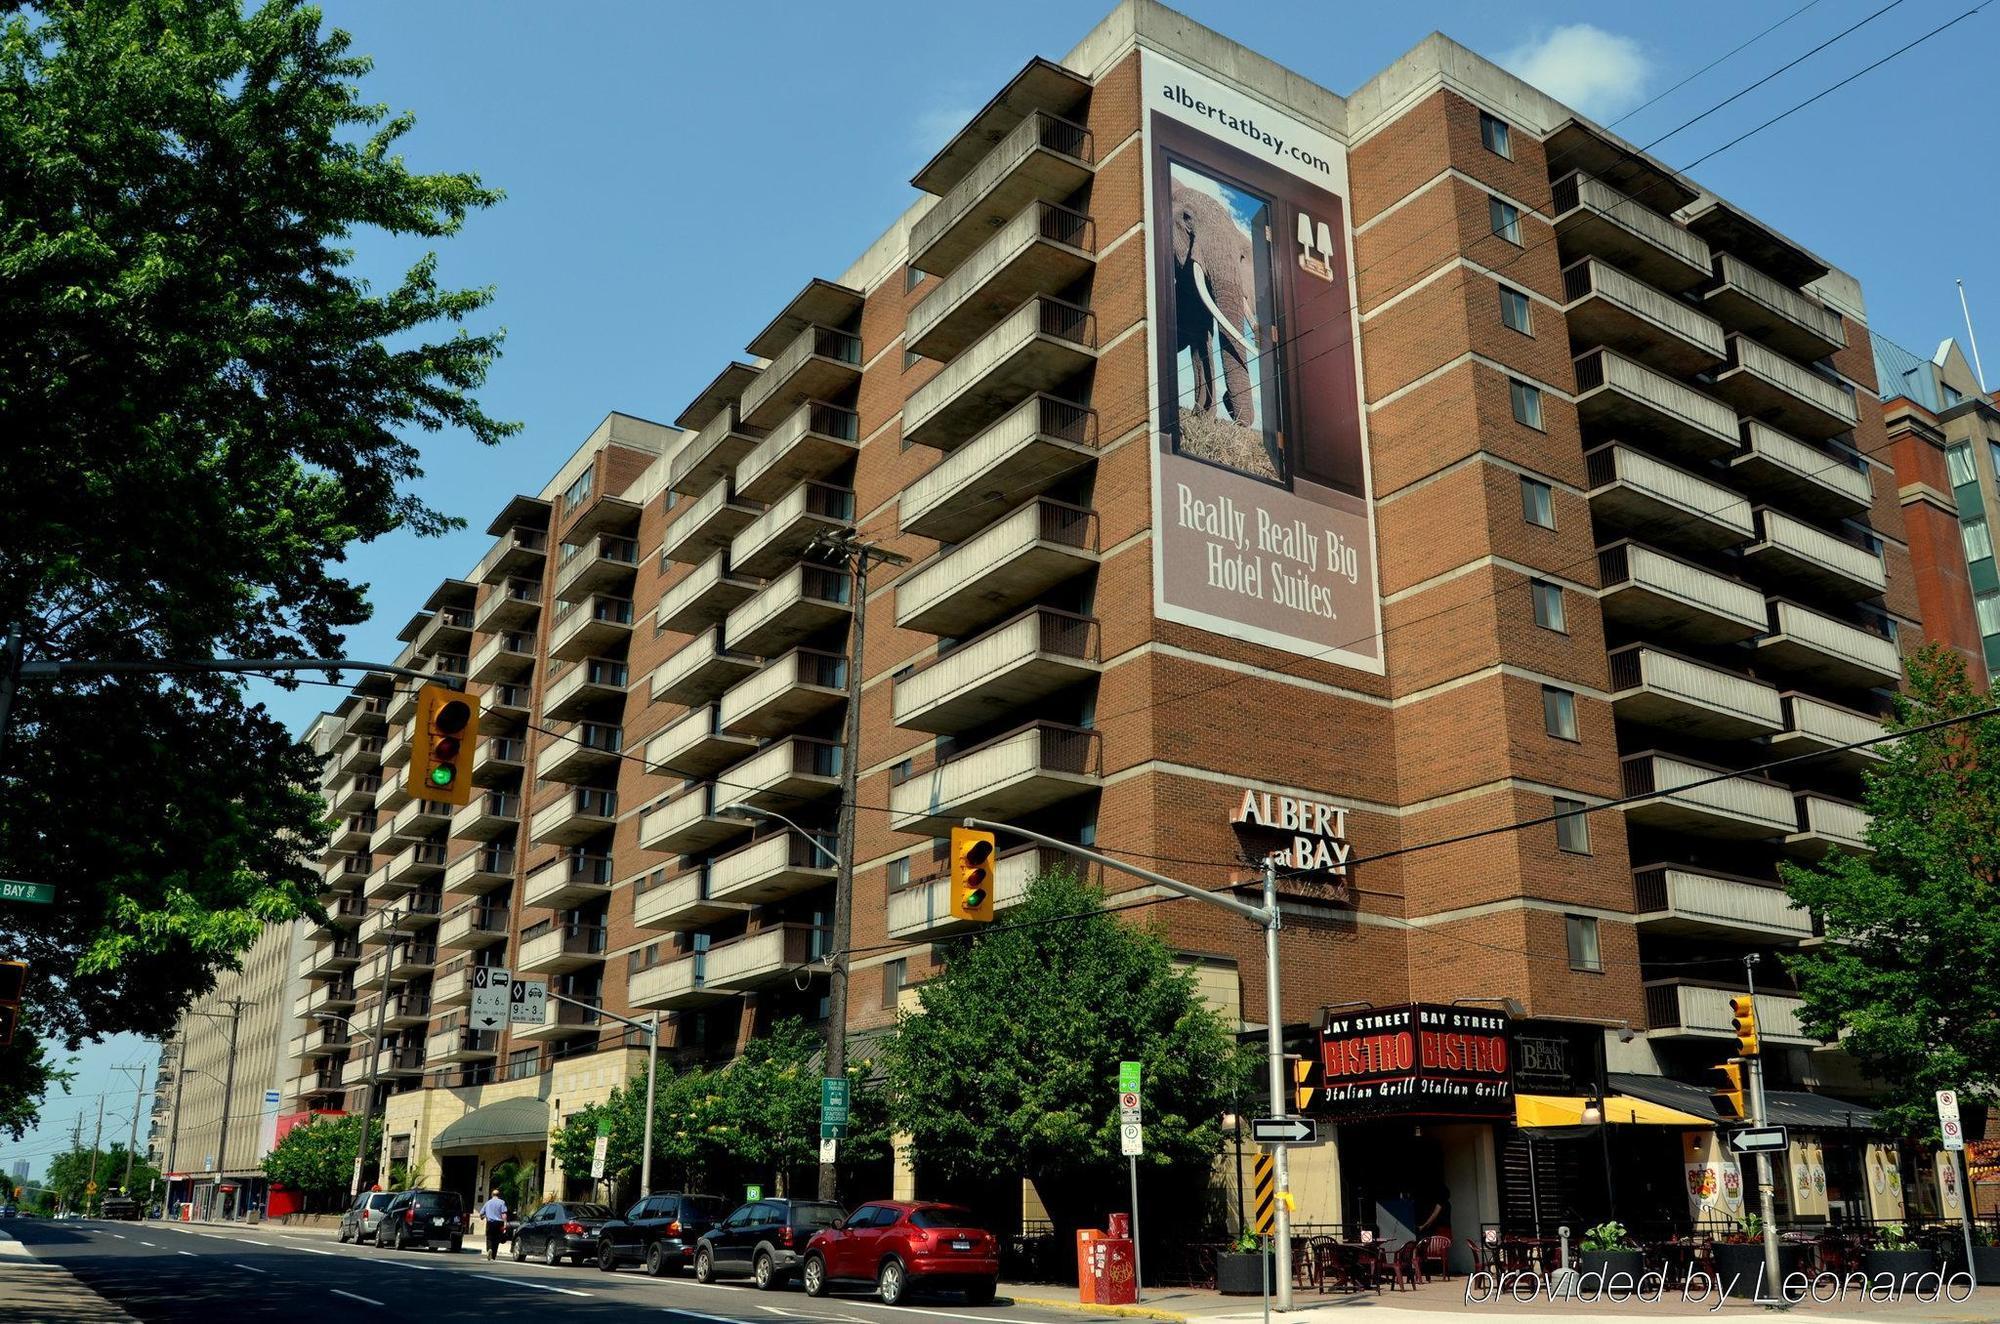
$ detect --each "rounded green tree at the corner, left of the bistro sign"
[886,872,1254,1236]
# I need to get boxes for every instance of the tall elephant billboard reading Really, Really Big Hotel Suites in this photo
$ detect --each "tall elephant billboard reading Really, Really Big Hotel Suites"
[1140,50,1382,674]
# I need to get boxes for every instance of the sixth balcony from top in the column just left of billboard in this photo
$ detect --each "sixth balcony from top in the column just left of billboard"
[894,606,1100,736]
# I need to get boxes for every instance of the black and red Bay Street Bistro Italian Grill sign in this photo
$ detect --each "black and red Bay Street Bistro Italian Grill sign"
[1308,1002,1514,1120]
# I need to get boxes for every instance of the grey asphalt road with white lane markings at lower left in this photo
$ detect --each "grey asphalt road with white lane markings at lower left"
[0,1218,1074,1324]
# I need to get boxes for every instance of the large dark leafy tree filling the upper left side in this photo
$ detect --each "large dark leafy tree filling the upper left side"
[0,0,512,1136]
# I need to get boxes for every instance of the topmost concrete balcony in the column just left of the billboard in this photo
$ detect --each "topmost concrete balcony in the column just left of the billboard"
[910,112,1096,276]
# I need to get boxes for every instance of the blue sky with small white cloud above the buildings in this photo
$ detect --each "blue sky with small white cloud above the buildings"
[23,0,2000,1164]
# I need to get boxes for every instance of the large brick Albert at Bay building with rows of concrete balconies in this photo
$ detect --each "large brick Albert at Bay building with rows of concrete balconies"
[294,0,1924,1232]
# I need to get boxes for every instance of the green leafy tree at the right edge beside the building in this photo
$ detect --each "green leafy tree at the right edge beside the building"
[1782,644,2000,1136]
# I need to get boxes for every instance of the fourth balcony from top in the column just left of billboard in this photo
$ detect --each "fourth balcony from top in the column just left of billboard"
[902,394,1098,542]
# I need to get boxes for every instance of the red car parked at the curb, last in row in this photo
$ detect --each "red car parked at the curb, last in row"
[800,1200,1000,1306]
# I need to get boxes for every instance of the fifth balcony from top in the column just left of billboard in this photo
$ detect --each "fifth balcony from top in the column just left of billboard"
[896,496,1098,638]
